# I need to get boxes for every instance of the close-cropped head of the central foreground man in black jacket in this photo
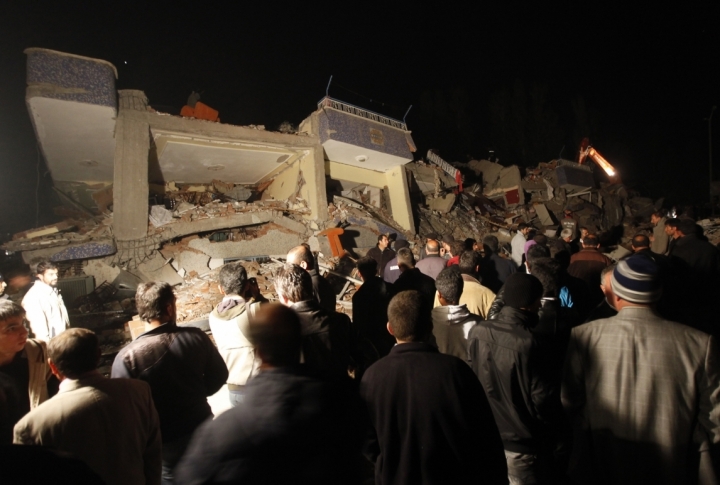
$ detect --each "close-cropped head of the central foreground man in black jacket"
[387,290,432,343]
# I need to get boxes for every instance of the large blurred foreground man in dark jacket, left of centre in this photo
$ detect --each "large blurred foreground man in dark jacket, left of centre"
[175,304,362,485]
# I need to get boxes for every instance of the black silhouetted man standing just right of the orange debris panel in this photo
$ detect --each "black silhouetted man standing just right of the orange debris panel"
[352,258,390,357]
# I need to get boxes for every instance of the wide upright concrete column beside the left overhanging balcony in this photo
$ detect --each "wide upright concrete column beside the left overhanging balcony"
[113,89,150,241]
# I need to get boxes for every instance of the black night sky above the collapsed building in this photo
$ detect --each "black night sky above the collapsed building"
[0,1,720,233]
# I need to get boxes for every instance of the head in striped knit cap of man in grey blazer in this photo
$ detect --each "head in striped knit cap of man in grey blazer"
[610,256,662,311]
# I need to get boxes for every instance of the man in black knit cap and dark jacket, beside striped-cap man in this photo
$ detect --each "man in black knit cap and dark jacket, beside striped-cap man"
[468,273,562,483]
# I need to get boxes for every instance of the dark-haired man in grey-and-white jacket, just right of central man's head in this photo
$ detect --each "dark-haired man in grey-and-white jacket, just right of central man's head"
[432,268,482,360]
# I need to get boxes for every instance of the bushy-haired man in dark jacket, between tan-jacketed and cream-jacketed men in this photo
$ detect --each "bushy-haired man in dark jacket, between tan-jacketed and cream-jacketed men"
[112,281,228,483]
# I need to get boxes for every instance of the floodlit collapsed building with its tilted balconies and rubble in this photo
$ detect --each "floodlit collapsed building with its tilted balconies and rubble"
[3,48,708,366]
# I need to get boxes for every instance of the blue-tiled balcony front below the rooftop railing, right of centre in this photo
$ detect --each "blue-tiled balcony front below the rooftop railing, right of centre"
[318,108,413,161]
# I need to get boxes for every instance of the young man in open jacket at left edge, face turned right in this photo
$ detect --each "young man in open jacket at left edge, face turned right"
[0,300,57,444]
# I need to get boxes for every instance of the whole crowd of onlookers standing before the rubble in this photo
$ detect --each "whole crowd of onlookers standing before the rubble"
[0,213,720,485]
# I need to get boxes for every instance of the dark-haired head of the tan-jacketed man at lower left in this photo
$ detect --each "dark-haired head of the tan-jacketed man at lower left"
[48,328,100,380]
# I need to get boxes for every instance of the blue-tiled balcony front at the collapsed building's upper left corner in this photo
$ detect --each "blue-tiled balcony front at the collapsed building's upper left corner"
[25,49,117,109]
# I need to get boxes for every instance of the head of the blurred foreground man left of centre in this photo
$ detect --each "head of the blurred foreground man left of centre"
[247,302,300,369]
